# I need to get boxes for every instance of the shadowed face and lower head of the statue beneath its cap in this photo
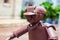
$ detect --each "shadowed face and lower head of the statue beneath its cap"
[25,14,44,24]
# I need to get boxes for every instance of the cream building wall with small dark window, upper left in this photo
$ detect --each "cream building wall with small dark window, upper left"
[0,0,21,19]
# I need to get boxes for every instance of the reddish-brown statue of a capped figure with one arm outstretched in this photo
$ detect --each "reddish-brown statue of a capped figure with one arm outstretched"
[8,6,57,40]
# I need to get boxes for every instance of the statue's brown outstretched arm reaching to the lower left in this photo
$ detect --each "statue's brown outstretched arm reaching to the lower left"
[6,26,28,40]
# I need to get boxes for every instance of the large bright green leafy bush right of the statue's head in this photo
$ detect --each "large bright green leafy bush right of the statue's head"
[40,2,60,20]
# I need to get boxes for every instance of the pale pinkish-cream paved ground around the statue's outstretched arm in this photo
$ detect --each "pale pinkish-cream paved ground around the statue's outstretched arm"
[0,20,60,40]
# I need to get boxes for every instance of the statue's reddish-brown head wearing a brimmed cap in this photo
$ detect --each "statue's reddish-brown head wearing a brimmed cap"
[24,7,46,24]
